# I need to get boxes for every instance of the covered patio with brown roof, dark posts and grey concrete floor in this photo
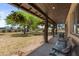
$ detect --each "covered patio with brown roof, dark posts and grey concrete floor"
[9,3,79,56]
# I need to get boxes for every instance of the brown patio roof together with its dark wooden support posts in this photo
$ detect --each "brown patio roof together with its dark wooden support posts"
[12,3,71,43]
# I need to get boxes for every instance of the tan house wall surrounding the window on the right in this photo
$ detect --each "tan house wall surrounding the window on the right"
[65,3,79,44]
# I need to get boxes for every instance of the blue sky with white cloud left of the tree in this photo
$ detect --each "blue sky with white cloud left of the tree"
[0,3,18,27]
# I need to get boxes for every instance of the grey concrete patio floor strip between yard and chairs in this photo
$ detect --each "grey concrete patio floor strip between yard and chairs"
[29,36,58,56]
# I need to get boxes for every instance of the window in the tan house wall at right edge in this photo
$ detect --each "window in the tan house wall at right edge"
[72,4,79,35]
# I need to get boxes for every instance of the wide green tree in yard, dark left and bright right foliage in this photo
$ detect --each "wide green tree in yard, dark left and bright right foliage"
[6,11,43,34]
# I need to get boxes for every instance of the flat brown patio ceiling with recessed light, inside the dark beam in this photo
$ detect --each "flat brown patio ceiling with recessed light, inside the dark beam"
[30,3,71,23]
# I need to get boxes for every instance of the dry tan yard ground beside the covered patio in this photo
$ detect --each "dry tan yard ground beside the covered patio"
[0,33,51,56]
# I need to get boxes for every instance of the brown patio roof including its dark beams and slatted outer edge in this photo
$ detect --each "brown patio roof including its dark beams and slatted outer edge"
[12,3,71,24]
